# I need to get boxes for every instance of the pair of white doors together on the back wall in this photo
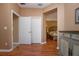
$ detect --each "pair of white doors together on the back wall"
[19,16,42,44]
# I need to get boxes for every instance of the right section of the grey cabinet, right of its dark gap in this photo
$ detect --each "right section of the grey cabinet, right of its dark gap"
[71,34,79,56]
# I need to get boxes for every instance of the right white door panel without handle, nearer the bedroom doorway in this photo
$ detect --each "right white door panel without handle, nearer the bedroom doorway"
[32,16,42,43]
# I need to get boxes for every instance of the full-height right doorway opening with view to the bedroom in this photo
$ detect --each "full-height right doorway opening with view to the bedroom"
[44,8,58,46]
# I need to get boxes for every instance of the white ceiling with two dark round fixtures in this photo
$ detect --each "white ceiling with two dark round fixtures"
[18,3,51,8]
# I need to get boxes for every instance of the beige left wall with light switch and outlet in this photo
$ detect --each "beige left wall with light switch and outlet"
[0,3,19,49]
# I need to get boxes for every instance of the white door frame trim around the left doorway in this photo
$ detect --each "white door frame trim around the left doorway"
[11,9,20,50]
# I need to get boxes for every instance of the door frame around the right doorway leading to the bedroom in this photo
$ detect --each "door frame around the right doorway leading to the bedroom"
[43,8,59,49]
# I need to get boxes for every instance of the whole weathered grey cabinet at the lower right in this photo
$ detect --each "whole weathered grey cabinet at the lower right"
[59,32,79,56]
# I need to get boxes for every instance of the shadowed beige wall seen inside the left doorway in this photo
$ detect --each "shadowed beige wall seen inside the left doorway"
[13,14,19,43]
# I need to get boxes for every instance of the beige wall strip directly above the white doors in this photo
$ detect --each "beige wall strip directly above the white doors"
[20,8,42,16]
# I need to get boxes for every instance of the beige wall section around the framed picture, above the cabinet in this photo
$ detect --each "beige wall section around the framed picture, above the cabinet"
[64,3,79,31]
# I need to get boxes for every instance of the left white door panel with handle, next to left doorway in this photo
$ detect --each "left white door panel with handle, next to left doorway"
[19,17,31,44]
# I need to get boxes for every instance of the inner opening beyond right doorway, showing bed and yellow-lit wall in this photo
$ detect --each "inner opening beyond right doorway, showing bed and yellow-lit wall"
[46,20,57,42]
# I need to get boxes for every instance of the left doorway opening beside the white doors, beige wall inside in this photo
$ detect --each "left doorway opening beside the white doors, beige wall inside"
[11,10,19,49]
